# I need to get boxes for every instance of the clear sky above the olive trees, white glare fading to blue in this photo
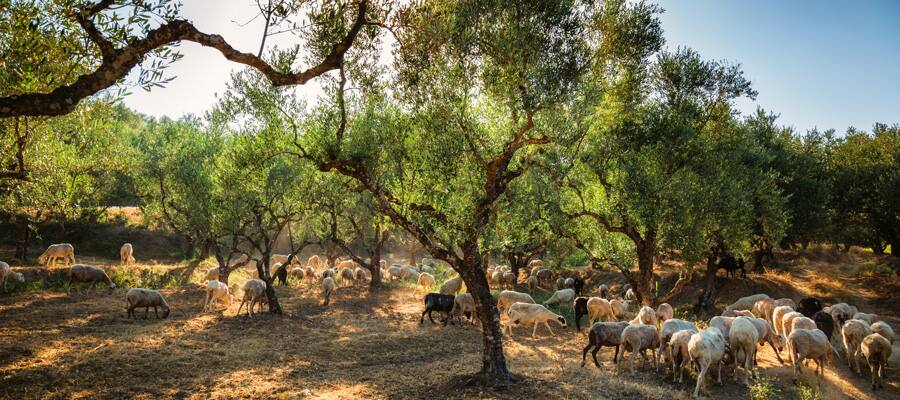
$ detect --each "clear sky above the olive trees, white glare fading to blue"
[125,0,900,133]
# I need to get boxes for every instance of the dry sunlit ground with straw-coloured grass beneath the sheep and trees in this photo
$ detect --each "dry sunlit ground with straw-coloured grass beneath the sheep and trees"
[0,248,900,399]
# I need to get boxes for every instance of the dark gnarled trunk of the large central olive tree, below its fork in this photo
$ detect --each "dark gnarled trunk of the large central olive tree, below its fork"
[455,251,510,386]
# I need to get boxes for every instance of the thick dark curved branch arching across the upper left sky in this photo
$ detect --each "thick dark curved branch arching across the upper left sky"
[0,0,368,118]
